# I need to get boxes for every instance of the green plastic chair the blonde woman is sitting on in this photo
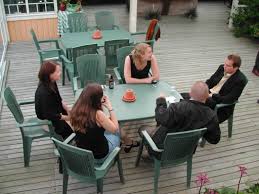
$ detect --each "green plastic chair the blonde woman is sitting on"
[113,46,134,84]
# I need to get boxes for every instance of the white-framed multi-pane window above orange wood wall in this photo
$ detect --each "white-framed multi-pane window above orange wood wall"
[4,0,56,15]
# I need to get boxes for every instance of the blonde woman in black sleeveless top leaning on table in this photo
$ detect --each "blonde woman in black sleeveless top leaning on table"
[124,43,159,83]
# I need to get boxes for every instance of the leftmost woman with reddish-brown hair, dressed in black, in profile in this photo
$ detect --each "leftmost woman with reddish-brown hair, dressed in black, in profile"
[35,61,73,139]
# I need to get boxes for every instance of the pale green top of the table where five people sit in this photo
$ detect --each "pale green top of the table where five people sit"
[75,81,182,122]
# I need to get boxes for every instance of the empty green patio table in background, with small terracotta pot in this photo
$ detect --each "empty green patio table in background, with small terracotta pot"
[59,29,134,55]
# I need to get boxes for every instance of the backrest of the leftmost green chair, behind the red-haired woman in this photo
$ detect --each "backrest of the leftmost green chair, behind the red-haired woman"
[4,87,24,123]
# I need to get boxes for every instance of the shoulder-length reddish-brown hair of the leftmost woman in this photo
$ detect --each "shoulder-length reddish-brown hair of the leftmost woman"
[38,61,59,88]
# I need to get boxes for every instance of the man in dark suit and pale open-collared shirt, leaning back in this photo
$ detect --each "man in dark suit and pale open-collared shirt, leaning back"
[206,54,247,123]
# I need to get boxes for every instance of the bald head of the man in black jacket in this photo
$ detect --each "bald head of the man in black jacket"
[190,81,209,103]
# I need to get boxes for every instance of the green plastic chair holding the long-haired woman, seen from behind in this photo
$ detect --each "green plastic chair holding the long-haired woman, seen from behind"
[51,138,124,194]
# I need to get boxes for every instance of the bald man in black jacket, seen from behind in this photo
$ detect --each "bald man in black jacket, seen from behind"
[139,81,221,158]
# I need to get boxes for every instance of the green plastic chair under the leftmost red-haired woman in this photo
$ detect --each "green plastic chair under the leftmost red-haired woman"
[4,87,52,167]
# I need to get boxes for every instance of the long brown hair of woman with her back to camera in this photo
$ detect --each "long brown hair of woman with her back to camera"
[70,83,103,133]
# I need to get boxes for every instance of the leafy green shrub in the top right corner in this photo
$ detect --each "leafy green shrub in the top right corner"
[232,0,259,38]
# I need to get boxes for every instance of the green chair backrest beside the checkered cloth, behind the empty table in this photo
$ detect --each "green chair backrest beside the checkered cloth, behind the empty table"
[67,12,87,32]
